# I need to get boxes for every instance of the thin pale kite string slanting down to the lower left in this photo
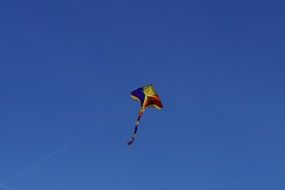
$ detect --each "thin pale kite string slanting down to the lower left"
[0,106,131,189]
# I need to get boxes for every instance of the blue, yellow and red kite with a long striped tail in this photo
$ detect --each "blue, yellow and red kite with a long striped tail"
[128,84,163,145]
